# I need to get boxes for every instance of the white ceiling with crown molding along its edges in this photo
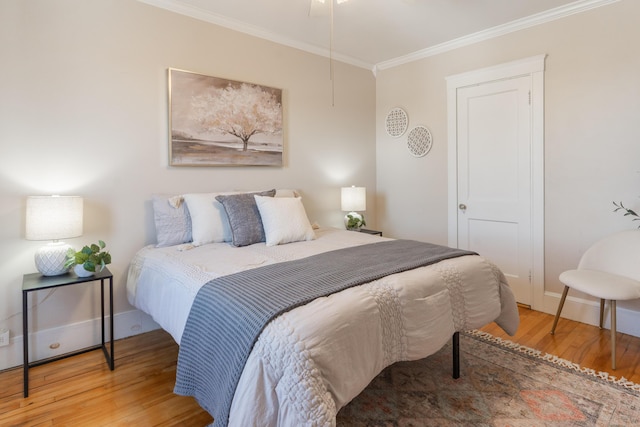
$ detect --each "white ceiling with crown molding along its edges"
[140,0,618,72]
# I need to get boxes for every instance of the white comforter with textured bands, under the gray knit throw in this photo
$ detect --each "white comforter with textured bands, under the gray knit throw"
[127,229,519,426]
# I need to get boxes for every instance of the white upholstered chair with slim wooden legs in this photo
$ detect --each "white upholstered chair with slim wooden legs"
[551,230,640,370]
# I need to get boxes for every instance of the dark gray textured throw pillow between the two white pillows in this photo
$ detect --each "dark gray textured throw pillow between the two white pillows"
[216,190,276,246]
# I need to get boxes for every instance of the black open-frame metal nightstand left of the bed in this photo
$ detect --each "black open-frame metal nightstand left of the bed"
[22,268,115,397]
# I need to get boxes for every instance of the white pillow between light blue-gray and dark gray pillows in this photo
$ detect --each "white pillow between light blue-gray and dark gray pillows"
[184,193,231,246]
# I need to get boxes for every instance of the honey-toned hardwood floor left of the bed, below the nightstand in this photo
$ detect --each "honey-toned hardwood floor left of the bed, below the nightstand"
[0,330,212,427]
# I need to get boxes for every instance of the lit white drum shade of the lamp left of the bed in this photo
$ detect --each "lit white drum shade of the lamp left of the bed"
[26,196,83,240]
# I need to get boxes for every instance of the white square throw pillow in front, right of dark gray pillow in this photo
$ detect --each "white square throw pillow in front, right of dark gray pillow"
[254,196,316,246]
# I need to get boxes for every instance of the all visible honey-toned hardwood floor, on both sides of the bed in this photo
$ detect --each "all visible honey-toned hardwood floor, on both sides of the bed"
[0,308,640,426]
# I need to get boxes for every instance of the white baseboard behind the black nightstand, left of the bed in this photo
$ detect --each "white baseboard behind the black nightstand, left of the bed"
[0,310,159,371]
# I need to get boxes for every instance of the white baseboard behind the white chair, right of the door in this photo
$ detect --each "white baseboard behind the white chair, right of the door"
[542,291,640,337]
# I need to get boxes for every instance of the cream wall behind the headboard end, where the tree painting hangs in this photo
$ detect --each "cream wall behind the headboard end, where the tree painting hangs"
[0,0,376,369]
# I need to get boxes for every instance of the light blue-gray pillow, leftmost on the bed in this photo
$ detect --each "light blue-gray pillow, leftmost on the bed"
[152,194,191,248]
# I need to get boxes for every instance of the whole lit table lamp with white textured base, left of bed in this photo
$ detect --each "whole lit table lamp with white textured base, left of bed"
[25,196,83,276]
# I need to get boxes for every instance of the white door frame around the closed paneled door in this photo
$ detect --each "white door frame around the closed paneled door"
[446,54,547,310]
